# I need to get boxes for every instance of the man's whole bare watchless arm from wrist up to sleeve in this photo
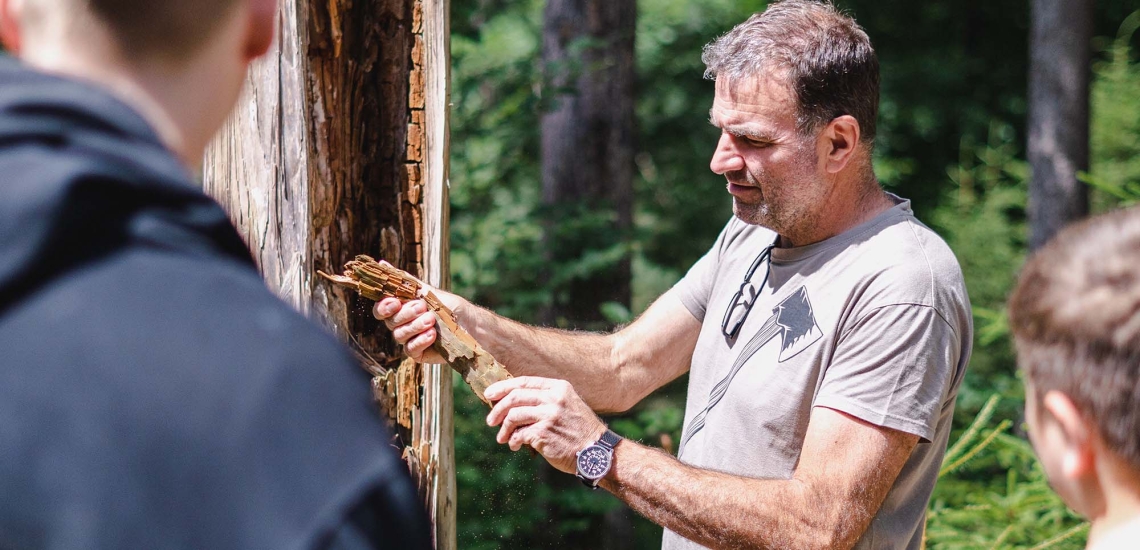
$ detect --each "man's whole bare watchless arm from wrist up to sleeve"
[456,290,701,412]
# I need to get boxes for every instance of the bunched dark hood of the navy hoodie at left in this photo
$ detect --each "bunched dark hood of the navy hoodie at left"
[0,56,253,313]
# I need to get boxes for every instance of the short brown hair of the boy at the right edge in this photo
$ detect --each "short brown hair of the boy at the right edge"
[1009,207,1140,469]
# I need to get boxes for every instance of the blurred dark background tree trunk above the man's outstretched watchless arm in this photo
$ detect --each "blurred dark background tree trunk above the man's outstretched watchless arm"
[542,0,637,327]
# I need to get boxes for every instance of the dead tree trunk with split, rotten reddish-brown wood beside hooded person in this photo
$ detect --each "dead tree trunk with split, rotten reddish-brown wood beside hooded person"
[203,0,455,549]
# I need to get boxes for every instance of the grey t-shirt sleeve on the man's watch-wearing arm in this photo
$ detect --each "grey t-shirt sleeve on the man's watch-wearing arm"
[815,304,961,442]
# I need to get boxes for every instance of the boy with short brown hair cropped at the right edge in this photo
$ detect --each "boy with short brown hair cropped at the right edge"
[1009,208,1140,550]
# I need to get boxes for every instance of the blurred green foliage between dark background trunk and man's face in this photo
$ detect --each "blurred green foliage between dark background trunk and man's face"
[634,0,765,275]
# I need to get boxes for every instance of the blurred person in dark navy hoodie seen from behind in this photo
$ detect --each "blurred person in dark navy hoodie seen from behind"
[0,0,430,549]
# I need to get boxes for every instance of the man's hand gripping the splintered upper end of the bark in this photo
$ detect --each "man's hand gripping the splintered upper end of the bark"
[372,286,466,363]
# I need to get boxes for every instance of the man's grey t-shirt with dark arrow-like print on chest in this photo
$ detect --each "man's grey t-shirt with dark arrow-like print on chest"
[662,196,974,550]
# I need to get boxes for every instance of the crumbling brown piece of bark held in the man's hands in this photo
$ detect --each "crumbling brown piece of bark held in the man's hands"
[317,256,512,406]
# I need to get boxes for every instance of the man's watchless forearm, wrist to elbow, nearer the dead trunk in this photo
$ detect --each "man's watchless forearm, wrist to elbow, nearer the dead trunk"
[456,301,628,412]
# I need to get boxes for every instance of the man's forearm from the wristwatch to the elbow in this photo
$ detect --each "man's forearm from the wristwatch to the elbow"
[602,440,857,549]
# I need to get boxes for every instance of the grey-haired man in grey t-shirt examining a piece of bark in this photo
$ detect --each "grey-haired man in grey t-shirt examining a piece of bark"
[375,0,972,549]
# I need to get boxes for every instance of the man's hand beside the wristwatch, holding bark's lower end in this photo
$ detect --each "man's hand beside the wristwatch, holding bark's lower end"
[483,377,605,474]
